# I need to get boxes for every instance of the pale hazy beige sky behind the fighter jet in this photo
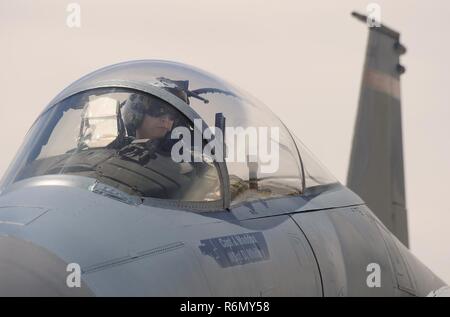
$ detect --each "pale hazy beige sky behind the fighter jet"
[0,0,450,283]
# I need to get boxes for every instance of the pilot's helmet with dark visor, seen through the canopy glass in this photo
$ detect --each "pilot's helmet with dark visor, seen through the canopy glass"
[122,78,189,135]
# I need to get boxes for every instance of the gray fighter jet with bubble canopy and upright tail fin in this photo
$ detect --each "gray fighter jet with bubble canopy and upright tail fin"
[0,14,446,297]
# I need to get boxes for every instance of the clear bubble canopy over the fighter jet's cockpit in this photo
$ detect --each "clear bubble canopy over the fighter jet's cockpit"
[1,60,337,205]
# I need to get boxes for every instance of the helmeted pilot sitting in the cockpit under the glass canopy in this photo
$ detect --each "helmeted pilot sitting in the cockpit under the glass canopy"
[118,82,206,198]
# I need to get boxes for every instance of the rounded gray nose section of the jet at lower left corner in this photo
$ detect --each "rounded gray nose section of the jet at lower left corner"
[0,236,93,297]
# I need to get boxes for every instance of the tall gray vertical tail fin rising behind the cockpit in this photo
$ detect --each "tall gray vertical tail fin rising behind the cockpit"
[347,13,408,246]
